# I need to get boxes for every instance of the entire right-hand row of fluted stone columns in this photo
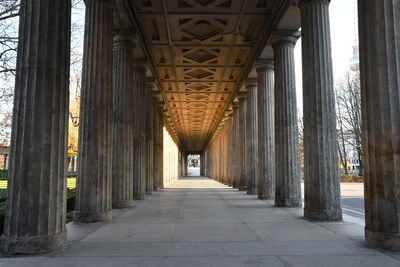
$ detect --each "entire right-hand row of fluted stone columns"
[206,0,400,249]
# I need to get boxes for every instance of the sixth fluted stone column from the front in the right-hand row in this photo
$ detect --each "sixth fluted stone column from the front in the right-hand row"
[239,92,247,191]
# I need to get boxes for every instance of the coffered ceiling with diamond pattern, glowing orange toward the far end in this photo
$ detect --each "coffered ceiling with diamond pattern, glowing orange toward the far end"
[132,0,276,151]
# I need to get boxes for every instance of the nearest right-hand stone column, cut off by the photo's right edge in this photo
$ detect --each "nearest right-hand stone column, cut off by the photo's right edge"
[358,0,400,250]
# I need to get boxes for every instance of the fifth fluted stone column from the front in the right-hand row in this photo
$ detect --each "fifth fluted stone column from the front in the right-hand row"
[246,79,258,194]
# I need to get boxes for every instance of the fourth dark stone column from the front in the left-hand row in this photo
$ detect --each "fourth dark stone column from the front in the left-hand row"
[133,60,147,200]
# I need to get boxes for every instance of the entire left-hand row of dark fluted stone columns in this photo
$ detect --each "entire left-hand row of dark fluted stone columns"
[1,0,163,254]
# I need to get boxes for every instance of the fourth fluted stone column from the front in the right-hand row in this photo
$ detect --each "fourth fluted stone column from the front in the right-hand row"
[257,60,275,199]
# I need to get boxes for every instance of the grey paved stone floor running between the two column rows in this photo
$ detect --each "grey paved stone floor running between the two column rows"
[0,177,400,267]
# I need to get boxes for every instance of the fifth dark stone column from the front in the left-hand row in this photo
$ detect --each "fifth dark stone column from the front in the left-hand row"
[144,78,155,194]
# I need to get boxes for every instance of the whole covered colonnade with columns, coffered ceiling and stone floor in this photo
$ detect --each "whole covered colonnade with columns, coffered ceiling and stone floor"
[1,0,400,258]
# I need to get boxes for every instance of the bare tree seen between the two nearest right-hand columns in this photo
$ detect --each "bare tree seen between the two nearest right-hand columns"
[336,71,363,175]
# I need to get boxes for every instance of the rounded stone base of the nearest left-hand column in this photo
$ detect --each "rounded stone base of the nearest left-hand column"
[1,231,67,255]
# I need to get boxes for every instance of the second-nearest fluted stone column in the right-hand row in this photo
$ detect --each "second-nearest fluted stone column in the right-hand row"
[299,0,342,221]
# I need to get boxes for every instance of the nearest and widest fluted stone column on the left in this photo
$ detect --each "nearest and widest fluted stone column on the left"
[1,0,71,254]
